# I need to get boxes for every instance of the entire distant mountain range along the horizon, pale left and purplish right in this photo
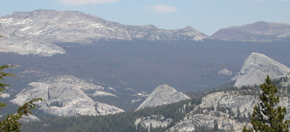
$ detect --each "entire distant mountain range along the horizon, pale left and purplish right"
[0,9,290,56]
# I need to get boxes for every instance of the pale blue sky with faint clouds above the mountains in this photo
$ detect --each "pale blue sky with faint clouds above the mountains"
[0,0,290,35]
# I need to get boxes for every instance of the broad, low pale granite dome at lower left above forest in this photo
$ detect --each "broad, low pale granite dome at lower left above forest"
[11,75,124,116]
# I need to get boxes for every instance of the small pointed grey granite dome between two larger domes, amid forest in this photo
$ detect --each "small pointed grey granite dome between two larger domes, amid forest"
[136,84,190,110]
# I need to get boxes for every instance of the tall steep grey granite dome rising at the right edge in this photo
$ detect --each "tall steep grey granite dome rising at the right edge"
[233,53,290,87]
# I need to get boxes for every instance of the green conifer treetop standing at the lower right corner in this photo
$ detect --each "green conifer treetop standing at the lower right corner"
[243,75,290,132]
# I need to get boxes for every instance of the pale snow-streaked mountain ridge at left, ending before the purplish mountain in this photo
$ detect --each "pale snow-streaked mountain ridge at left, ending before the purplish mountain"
[0,10,208,56]
